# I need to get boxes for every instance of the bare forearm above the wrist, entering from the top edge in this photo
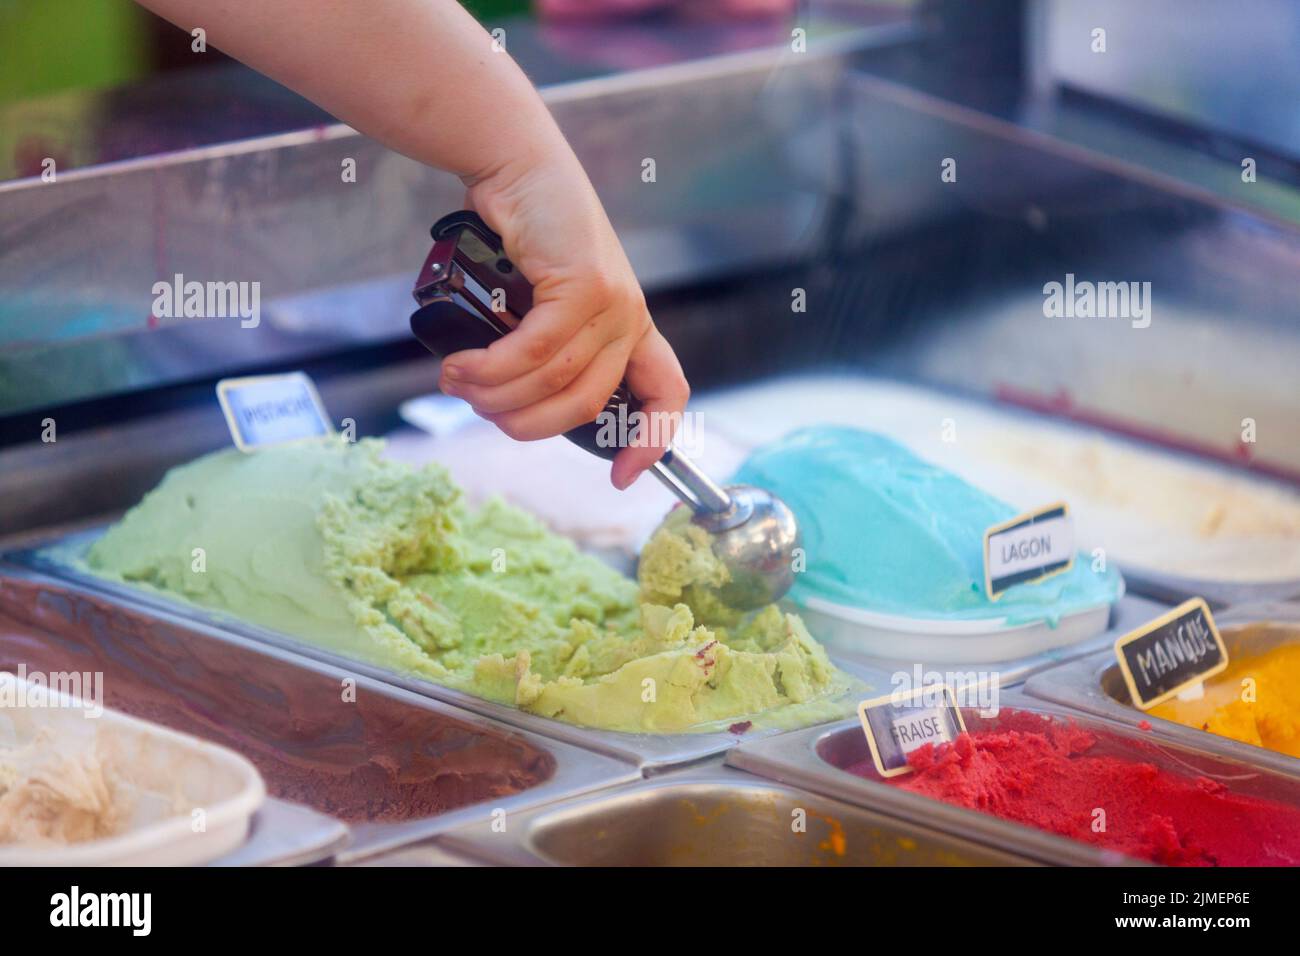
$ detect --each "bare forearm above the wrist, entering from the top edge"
[139,0,569,182]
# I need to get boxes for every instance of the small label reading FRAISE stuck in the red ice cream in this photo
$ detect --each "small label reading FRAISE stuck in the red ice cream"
[858,684,966,777]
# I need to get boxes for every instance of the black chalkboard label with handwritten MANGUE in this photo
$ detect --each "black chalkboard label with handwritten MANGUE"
[1115,597,1227,710]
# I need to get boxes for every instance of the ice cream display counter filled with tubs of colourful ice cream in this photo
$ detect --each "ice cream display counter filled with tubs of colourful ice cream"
[0,0,1300,877]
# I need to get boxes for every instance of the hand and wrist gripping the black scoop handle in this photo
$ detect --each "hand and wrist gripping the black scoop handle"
[439,149,690,489]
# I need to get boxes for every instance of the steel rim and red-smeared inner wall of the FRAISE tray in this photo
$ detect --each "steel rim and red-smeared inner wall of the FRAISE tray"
[727,692,1300,866]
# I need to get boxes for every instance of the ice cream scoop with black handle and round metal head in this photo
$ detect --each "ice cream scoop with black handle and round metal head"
[411,211,800,607]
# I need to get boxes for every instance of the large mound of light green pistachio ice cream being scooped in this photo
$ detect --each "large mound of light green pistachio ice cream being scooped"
[87,440,857,732]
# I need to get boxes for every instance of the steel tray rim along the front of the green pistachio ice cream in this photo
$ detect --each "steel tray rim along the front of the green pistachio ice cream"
[0,529,888,771]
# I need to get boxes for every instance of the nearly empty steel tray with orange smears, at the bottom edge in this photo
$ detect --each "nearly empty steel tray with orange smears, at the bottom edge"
[431,764,1030,866]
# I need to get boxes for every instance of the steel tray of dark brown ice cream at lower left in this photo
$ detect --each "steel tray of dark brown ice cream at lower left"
[0,568,638,861]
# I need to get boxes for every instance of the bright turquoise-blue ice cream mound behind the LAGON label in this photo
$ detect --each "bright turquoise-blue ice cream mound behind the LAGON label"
[733,427,1123,626]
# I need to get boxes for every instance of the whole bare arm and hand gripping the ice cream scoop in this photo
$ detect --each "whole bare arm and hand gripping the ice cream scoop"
[140,0,689,488]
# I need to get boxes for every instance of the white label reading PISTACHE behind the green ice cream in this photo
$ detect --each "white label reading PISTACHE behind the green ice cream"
[217,372,334,451]
